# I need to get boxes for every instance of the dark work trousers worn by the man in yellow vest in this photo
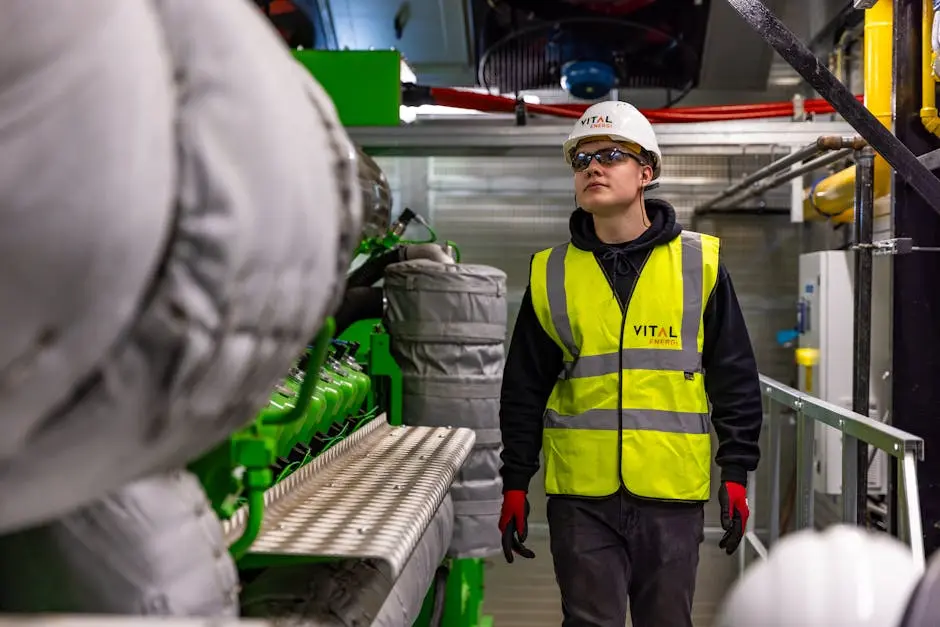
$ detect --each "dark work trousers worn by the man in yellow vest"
[548,493,705,627]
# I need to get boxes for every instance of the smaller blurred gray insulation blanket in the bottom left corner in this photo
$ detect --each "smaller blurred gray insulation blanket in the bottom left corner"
[0,472,238,616]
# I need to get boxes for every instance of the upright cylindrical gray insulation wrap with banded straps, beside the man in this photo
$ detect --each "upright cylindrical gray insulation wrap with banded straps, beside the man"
[385,260,506,558]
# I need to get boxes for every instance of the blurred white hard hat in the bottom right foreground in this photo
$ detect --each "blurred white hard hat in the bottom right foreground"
[716,525,921,627]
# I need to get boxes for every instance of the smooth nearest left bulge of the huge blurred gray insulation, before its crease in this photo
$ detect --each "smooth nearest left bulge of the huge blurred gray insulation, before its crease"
[0,0,176,472]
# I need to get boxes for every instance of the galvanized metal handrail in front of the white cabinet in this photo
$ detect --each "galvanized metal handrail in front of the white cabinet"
[738,375,925,572]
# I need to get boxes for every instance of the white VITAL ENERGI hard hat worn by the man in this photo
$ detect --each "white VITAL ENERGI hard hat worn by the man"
[564,100,663,181]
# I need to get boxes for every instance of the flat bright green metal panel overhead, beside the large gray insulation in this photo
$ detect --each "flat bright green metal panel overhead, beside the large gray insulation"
[293,50,401,126]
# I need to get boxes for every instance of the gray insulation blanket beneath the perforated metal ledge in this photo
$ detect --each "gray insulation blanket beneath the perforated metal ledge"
[242,496,454,627]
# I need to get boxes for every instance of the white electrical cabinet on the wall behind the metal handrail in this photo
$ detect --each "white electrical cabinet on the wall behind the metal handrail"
[797,251,887,494]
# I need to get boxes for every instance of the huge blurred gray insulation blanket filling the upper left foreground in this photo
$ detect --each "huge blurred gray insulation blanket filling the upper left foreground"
[0,0,362,533]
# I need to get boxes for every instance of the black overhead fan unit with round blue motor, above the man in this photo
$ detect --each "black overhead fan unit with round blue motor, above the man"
[473,0,709,104]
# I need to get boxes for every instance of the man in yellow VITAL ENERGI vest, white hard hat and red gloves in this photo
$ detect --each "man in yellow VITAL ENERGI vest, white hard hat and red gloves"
[499,102,762,627]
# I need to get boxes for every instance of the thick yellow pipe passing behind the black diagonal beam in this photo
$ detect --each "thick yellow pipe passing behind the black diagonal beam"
[803,0,892,222]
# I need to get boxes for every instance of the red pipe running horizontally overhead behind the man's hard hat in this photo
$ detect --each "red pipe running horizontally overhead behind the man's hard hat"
[422,87,862,123]
